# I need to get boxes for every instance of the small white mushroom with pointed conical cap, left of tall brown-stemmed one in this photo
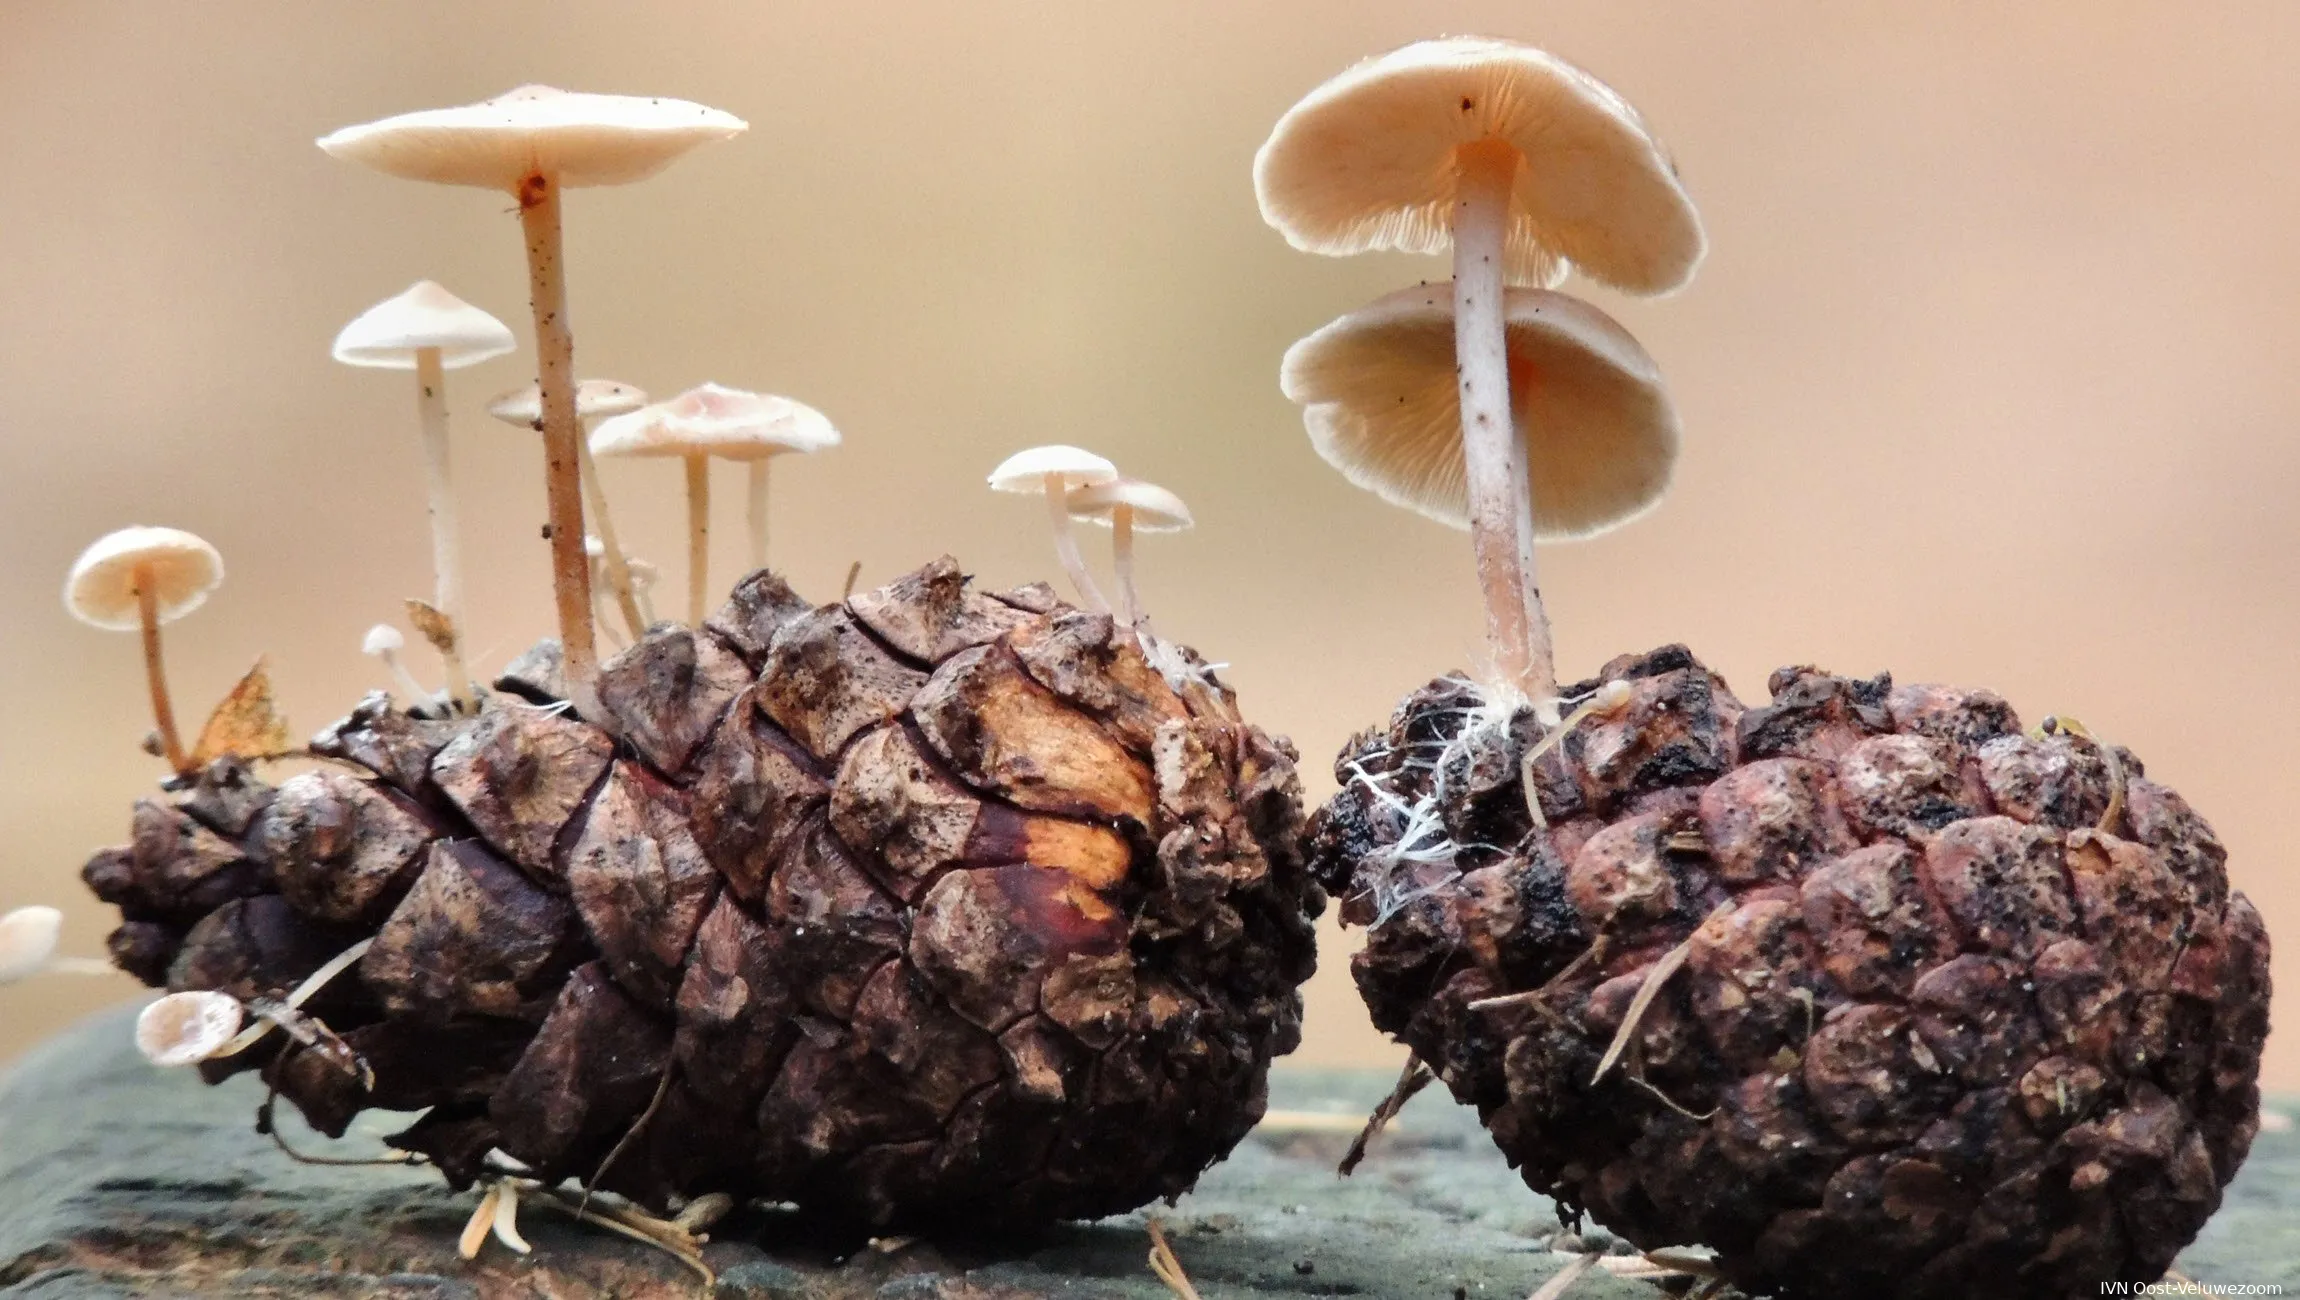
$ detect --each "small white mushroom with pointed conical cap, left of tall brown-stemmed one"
[334,281,518,711]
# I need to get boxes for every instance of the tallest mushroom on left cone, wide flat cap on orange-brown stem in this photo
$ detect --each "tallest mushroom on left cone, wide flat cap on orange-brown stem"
[320,85,748,716]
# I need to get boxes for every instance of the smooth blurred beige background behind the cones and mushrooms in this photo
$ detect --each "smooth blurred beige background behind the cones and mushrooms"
[0,0,2300,1088]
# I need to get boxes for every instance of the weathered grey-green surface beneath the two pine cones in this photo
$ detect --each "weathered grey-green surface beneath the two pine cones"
[0,1012,2300,1300]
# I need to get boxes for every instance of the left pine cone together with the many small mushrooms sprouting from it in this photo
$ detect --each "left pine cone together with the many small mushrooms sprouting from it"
[35,75,1325,1259]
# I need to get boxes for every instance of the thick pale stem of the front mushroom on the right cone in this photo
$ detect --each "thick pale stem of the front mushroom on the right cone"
[1454,140,1557,699]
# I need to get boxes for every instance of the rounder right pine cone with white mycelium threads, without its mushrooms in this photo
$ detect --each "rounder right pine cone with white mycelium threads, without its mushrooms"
[1311,647,2268,1300]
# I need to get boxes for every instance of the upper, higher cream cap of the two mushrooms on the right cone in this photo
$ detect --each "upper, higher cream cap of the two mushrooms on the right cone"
[1254,37,1707,295]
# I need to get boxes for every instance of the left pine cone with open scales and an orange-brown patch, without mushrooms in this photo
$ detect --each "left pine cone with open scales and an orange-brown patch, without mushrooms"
[85,559,1325,1226]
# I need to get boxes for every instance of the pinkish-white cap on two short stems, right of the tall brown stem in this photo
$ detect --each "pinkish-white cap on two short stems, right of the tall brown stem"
[591,384,840,626]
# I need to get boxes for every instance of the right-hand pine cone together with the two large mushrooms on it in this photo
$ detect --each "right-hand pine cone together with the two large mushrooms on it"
[1256,39,2268,1300]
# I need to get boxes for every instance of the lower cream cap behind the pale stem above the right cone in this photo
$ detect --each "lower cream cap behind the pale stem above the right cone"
[1279,285,1679,541]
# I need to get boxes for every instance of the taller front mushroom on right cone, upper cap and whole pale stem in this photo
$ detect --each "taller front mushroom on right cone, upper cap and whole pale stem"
[1254,37,1704,699]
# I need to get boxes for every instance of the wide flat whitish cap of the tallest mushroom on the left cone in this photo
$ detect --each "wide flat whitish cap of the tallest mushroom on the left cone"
[320,85,750,191]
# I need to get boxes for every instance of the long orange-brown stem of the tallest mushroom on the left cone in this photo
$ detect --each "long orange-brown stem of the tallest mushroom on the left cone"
[518,175,603,718]
